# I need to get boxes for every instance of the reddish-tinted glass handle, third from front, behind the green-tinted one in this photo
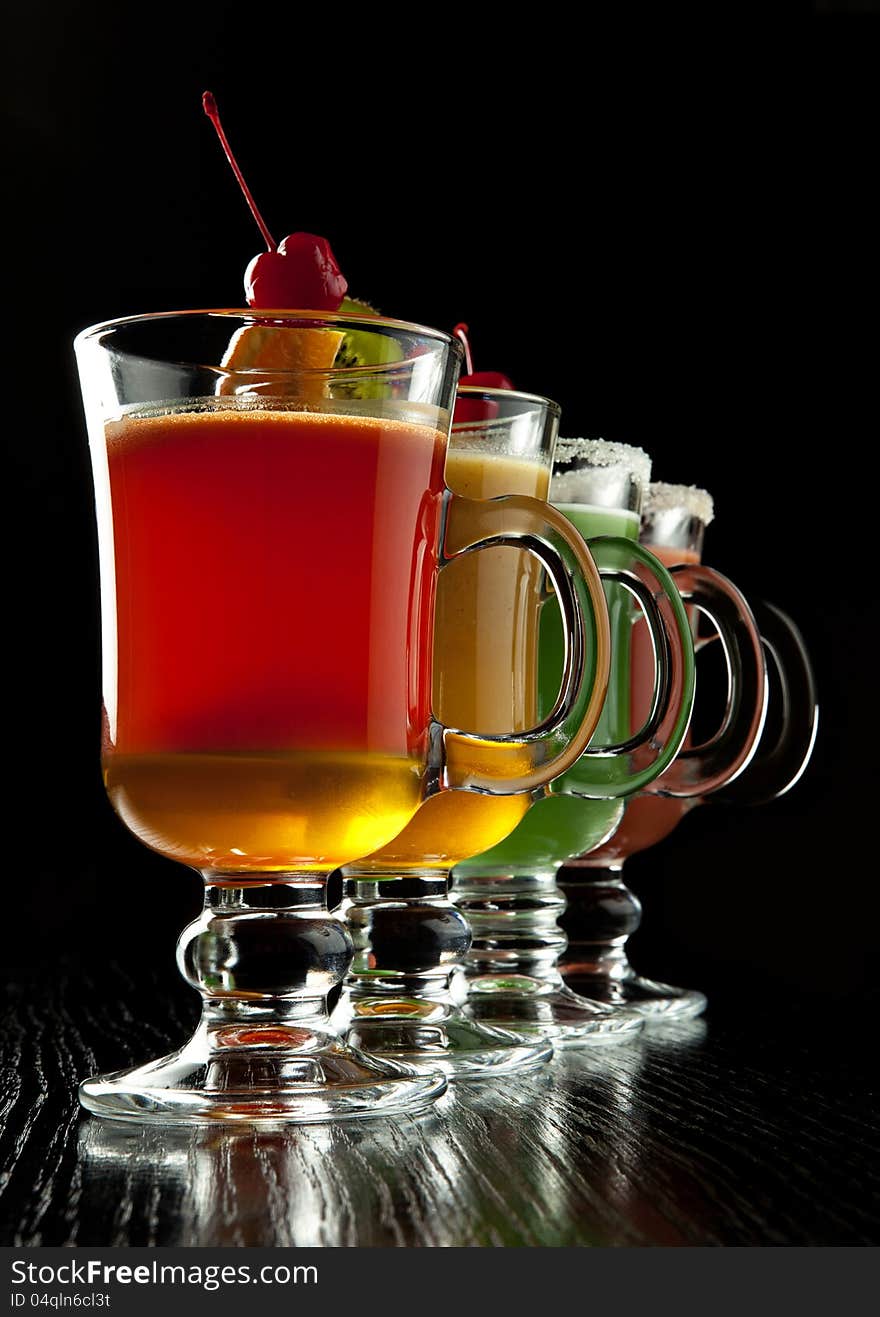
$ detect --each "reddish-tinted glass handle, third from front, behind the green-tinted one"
[646,564,768,799]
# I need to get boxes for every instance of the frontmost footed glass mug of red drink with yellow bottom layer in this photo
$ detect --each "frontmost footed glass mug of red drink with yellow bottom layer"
[75,311,609,1122]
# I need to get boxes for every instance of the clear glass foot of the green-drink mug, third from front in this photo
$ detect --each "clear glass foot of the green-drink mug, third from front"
[465,975,644,1047]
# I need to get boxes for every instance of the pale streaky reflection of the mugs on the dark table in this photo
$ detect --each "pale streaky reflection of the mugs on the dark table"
[76,1021,706,1247]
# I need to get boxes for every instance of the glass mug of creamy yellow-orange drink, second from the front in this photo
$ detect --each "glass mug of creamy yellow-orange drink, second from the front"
[333,387,640,1080]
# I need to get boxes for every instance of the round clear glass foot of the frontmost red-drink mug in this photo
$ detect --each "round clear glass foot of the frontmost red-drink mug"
[79,1026,447,1125]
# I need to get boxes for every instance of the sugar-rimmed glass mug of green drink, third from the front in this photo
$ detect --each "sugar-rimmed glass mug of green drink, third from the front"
[453,439,763,1046]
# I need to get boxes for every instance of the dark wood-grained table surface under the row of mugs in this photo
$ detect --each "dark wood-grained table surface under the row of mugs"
[0,967,880,1247]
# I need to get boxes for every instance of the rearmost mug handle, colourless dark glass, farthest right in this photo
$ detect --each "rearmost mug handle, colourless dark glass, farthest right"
[713,601,819,805]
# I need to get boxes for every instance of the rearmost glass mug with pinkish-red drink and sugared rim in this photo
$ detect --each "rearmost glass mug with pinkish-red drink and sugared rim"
[557,483,818,1021]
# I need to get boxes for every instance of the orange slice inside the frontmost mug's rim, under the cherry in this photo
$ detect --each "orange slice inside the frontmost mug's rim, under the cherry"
[217,325,344,402]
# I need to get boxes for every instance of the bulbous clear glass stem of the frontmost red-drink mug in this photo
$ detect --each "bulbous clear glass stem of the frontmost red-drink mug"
[178,873,353,1047]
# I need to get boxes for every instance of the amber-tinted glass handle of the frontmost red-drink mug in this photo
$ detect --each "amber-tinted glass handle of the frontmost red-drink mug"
[429,491,611,795]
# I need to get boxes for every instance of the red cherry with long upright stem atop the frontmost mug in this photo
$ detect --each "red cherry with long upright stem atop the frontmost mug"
[202,91,348,311]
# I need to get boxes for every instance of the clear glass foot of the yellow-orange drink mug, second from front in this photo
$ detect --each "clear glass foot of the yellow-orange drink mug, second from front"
[335,997,553,1083]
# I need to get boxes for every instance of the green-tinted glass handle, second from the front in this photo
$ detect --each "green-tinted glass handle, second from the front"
[552,535,696,799]
